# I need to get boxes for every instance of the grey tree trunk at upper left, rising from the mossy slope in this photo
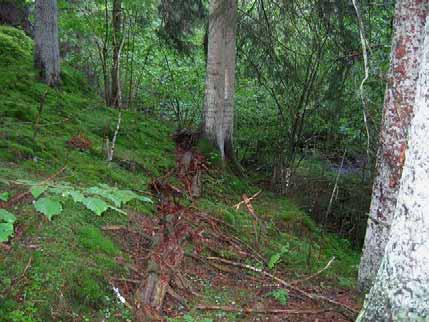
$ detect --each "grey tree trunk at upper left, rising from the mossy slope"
[34,0,60,86]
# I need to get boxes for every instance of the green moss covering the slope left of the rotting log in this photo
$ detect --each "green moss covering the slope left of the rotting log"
[0,27,171,322]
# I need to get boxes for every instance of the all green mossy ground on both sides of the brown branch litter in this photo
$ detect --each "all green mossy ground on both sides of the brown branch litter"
[0,27,358,322]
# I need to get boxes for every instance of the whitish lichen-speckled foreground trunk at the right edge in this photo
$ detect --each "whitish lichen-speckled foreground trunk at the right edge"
[358,16,429,321]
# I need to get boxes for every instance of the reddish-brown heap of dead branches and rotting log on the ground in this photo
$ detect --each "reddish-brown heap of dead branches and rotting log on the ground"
[105,147,357,321]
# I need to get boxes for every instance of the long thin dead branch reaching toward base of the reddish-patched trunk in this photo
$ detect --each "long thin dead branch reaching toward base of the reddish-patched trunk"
[207,257,359,320]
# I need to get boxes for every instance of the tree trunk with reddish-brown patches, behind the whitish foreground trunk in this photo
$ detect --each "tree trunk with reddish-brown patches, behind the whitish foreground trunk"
[358,0,429,291]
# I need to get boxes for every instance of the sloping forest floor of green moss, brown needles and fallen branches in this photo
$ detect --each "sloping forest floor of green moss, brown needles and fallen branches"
[0,27,361,322]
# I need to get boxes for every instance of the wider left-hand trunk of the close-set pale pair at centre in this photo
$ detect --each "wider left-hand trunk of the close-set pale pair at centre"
[203,0,226,160]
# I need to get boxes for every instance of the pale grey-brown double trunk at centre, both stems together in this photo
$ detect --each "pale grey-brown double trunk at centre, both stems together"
[203,0,237,160]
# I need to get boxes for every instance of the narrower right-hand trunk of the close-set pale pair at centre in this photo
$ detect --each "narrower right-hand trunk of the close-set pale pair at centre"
[223,0,237,160]
